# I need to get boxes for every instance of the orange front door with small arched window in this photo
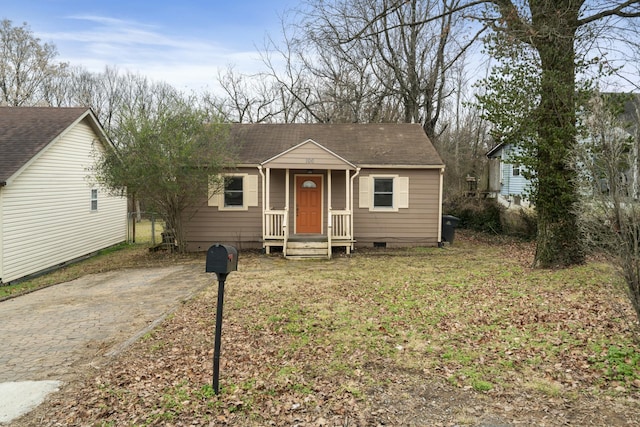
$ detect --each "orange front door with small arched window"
[296,175,322,234]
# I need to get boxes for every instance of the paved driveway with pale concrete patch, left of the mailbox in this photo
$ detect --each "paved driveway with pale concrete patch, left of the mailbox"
[0,263,211,424]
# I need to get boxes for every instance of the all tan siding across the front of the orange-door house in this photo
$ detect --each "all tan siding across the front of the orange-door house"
[180,168,441,251]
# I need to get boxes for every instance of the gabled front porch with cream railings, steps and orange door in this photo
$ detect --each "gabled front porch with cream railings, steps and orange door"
[259,140,360,258]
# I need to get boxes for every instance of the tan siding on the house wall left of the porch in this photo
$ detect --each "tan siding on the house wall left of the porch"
[185,168,262,251]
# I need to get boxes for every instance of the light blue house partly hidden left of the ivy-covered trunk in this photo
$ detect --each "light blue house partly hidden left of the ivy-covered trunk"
[487,143,531,207]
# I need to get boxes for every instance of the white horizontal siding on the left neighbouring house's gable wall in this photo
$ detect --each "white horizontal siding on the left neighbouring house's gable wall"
[0,122,127,282]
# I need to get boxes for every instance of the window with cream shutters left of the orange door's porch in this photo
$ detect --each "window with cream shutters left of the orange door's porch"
[207,174,258,210]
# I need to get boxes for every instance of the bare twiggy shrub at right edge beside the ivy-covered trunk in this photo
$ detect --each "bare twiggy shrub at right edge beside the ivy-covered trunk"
[572,92,640,320]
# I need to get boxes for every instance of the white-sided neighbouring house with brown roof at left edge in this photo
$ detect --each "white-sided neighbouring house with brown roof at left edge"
[0,107,127,284]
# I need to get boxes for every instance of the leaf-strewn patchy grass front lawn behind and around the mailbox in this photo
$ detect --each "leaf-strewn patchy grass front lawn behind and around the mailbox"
[15,233,640,426]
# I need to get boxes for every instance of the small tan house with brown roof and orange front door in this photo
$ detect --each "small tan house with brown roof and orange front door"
[186,124,444,257]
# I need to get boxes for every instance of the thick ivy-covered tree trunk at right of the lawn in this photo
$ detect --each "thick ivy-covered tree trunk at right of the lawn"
[534,5,584,268]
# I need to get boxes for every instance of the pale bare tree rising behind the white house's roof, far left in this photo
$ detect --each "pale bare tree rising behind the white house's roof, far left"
[0,19,67,106]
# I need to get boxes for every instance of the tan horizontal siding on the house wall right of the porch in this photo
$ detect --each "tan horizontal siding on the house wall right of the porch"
[354,169,441,247]
